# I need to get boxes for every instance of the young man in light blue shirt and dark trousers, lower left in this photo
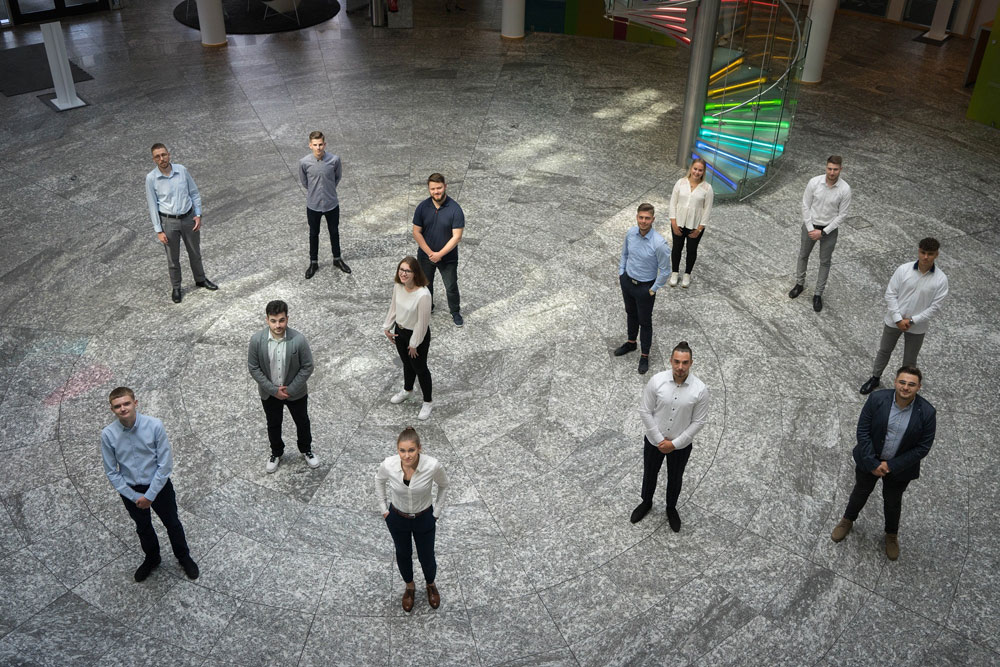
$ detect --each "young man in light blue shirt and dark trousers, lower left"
[101,387,198,581]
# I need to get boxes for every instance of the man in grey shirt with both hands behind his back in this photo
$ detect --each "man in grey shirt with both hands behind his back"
[299,131,351,280]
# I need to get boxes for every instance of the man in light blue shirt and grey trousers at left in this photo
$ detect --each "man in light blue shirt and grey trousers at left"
[146,144,219,303]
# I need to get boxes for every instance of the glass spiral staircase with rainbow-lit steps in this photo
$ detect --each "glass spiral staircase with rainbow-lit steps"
[605,0,809,199]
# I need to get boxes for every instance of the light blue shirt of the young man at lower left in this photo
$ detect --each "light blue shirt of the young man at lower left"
[101,413,174,502]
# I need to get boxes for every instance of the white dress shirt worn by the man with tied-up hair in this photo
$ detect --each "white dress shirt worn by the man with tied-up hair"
[639,371,712,449]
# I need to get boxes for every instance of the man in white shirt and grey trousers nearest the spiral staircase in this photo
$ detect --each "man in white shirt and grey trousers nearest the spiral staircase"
[788,155,851,313]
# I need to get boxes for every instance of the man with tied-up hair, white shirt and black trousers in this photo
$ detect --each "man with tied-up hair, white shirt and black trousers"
[631,341,711,533]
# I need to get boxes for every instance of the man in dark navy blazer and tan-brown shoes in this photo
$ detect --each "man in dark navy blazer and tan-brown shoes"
[830,366,937,560]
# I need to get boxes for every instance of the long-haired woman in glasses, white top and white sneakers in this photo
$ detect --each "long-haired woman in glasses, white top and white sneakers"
[382,256,433,420]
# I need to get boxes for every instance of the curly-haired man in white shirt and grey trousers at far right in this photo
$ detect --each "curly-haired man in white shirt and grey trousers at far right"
[860,237,948,394]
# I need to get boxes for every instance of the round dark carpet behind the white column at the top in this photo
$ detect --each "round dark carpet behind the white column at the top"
[174,0,340,35]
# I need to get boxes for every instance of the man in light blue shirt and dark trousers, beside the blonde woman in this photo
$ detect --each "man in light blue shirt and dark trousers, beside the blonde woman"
[615,204,670,374]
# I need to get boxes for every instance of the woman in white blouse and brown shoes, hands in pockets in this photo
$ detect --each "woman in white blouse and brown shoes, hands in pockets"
[375,427,448,611]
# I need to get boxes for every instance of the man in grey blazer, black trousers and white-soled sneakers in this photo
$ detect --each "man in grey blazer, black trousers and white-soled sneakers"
[247,300,319,473]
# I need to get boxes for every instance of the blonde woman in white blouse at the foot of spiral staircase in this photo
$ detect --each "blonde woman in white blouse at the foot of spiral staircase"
[667,158,715,287]
